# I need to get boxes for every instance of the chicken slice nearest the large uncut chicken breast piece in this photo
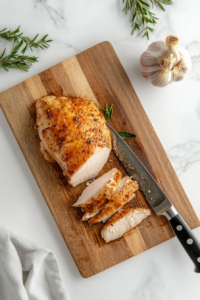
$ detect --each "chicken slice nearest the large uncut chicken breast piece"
[73,168,122,221]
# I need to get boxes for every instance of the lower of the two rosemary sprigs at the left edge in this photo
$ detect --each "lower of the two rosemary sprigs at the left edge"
[0,41,38,72]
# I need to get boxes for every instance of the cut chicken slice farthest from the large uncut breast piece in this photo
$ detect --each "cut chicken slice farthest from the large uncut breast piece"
[101,208,150,243]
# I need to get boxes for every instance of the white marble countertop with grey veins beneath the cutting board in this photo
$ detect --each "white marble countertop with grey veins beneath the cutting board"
[0,0,200,300]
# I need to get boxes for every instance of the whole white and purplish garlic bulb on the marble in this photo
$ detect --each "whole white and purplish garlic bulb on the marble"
[140,35,191,87]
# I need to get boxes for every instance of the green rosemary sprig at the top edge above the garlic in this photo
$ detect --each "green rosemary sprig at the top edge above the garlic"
[122,0,173,39]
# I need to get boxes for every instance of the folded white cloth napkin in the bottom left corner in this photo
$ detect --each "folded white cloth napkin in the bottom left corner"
[0,225,70,300]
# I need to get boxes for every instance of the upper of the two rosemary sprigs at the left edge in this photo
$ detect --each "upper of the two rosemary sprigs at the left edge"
[0,26,52,54]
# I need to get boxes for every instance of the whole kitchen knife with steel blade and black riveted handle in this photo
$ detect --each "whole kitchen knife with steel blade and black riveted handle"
[107,123,200,273]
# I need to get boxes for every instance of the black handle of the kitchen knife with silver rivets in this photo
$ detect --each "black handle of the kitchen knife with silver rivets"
[169,214,200,273]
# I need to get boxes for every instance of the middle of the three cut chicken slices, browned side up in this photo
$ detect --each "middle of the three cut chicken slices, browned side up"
[88,176,138,225]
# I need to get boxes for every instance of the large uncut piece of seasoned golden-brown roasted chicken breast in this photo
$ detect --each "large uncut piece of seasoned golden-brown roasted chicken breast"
[36,96,111,186]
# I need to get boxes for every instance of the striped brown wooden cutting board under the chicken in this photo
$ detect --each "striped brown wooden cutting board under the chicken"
[0,42,200,277]
